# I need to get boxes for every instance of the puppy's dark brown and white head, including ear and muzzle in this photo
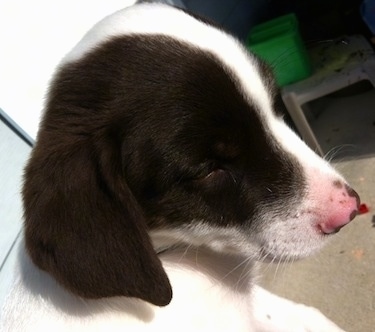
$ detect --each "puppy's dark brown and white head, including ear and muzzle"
[23,5,358,305]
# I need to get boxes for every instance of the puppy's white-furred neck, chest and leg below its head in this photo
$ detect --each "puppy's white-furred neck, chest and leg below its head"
[0,243,342,332]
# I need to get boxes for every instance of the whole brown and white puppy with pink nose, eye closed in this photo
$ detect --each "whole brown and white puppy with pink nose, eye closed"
[1,4,359,332]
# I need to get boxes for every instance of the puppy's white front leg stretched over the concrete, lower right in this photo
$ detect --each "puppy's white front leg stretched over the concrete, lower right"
[253,286,344,332]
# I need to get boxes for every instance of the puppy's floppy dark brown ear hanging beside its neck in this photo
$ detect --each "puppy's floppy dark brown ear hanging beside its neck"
[23,130,172,306]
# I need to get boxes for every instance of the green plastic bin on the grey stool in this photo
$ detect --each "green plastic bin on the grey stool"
[246,13,311,86]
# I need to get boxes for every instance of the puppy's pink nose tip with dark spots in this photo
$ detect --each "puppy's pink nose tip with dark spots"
[318,181,360,234]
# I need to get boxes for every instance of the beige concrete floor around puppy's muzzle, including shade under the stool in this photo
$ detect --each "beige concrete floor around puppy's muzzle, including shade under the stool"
[263,85,375,332]
